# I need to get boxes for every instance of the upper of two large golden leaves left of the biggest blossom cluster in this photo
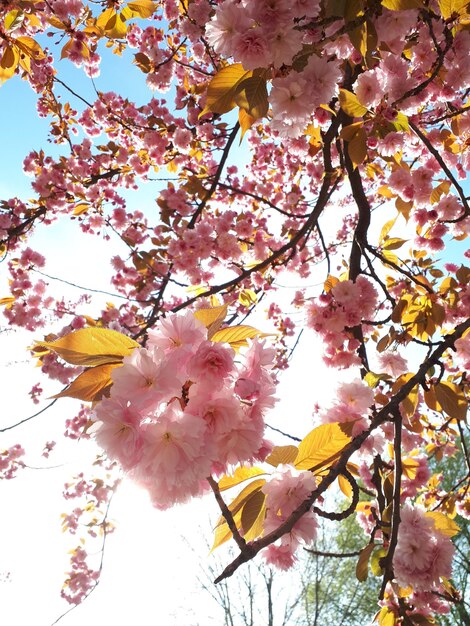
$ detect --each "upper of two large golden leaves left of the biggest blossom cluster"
[36,328,139,366]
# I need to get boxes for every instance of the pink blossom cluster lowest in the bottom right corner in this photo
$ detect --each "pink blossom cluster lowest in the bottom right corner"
[393,504,454,591]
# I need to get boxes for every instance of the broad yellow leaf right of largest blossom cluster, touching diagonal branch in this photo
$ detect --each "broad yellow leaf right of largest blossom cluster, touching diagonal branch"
[294,422,354,473]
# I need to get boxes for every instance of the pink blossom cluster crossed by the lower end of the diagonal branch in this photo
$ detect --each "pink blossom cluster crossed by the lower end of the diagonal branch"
[262,465,318,570]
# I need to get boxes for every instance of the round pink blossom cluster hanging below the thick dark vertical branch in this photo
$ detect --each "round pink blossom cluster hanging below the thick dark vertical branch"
[307,275,378,368]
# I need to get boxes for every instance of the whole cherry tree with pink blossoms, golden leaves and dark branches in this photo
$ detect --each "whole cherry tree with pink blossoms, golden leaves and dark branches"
[0,0,470,626]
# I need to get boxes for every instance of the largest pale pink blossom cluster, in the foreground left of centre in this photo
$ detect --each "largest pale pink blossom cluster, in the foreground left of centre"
[95,312,275,509]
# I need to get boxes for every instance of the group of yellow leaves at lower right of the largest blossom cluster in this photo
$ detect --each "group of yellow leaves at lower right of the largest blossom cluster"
[212,422,353,550]
